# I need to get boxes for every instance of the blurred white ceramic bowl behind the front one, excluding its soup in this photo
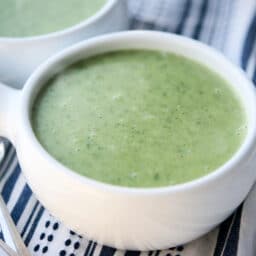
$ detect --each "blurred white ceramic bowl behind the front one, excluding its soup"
[0,0,128,88]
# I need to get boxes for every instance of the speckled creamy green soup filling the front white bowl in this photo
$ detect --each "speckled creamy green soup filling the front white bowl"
[32,50,247,187]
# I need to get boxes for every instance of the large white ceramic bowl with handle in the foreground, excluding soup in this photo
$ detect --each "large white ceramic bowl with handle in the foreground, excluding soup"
[0,31,256,250]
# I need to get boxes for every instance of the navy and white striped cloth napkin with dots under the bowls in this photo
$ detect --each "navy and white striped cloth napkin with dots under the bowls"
[0,0,256,256]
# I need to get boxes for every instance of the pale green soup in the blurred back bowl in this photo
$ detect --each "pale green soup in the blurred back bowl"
[0,0,107,37]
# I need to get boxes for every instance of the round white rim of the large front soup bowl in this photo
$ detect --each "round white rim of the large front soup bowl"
[20,30,256,196]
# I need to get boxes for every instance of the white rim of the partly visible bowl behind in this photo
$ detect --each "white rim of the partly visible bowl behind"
[0,0,119,43]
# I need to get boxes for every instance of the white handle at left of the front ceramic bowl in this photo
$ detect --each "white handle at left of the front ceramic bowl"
[0,82,21,143]
